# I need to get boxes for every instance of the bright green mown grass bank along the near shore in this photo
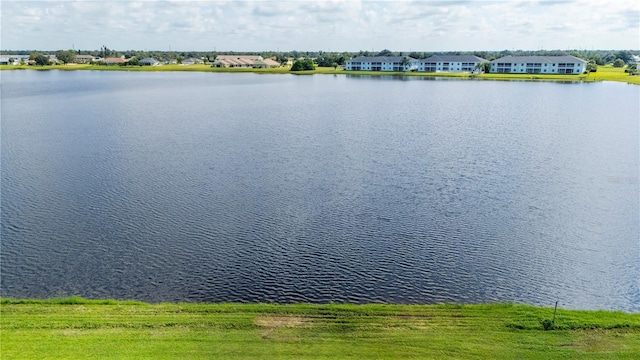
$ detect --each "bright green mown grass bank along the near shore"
[0,298,640,360]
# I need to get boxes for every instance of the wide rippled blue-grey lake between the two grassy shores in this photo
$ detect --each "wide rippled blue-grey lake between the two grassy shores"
[0,71,640,312]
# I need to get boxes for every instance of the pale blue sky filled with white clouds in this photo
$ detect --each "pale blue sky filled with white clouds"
[0,0,640,52]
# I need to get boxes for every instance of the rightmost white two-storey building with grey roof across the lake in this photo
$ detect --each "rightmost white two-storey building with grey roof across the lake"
[491,55,587,74]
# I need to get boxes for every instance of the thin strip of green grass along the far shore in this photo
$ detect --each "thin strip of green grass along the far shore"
[0,64,640,85]
